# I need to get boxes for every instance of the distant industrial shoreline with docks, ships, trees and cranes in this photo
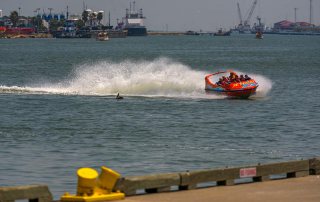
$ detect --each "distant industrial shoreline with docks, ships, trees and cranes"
[0,0,320,38]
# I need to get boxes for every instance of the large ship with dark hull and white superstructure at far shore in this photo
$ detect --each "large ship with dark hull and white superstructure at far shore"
[118,1,147,36]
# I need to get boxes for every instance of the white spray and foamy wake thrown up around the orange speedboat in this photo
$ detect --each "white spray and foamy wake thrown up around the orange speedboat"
[0,58,271,99]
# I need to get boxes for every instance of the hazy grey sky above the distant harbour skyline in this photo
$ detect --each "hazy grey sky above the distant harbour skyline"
[0,0,320,31]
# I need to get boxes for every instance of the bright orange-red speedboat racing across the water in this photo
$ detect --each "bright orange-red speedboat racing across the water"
[205,70,259,99]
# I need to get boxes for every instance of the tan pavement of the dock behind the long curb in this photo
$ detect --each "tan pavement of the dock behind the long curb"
[123,175,320,202]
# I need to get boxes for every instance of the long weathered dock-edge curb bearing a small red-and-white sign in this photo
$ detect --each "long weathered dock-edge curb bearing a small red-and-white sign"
[116,158,320,196]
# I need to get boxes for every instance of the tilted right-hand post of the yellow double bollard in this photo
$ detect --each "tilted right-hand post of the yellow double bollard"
[98,166,121,192]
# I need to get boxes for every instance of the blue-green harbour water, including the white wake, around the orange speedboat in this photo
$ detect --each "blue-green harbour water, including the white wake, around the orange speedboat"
[0,35,320,199]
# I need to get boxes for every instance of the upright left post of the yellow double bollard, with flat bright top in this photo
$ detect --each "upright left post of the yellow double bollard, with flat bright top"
[77,168,98,196]
